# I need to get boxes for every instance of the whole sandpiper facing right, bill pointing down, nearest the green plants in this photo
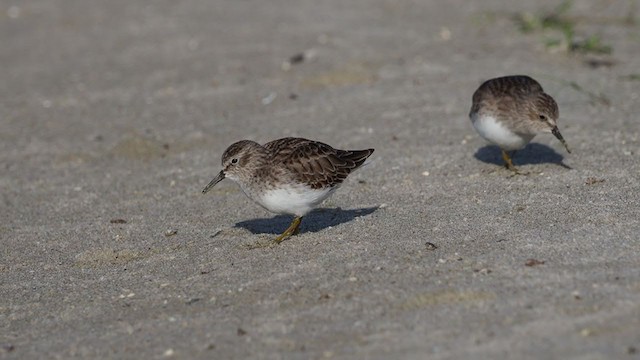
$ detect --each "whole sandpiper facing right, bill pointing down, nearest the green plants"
[469,75,571,174]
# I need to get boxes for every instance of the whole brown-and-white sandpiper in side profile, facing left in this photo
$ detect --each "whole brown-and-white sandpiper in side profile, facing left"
[202,137,373,243]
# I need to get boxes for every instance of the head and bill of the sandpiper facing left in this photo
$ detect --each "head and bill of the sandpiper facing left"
[202,140,264,194]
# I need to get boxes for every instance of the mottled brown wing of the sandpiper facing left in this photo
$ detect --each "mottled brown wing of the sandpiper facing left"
[274,139,373,189]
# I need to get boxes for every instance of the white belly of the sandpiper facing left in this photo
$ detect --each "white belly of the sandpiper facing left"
[254,185,337,216]
